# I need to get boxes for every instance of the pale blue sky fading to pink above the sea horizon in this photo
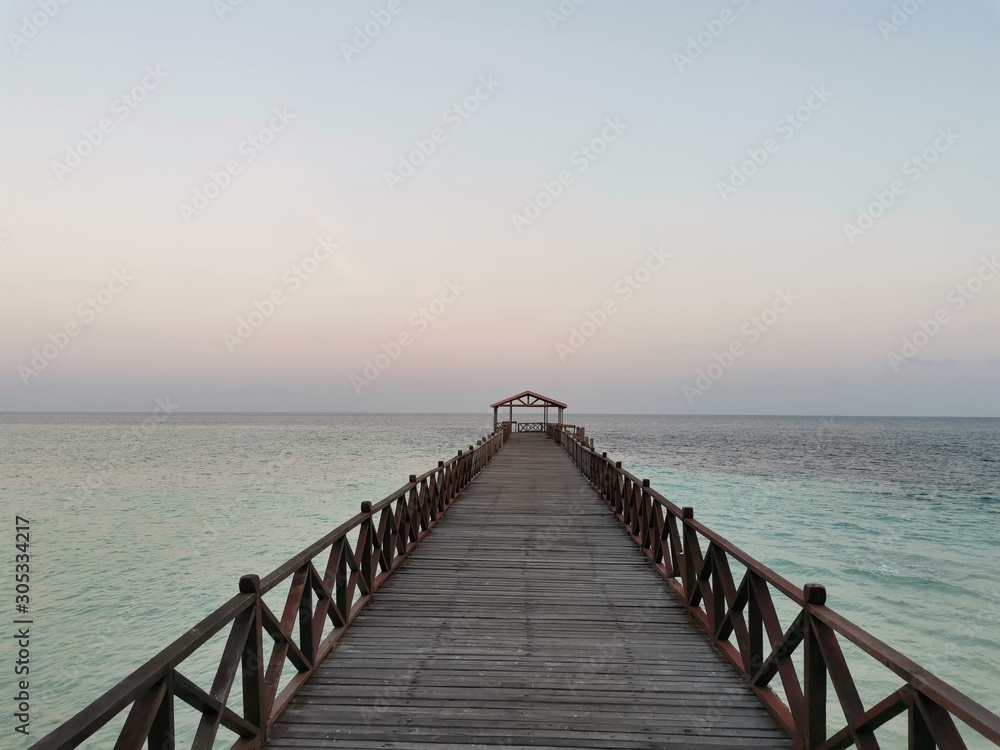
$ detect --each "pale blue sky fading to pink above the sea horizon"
[0,0,1000,417]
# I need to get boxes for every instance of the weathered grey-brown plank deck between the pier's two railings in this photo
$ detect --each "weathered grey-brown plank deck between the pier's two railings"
[266,433,792,750]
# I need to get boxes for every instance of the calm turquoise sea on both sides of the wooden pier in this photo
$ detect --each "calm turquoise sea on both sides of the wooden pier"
[0,414,1000,749]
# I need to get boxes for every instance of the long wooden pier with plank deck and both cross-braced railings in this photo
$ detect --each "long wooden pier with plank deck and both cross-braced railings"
[27,392,1000,750]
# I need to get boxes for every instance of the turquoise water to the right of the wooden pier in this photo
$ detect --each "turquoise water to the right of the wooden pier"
[581,417,1000,747]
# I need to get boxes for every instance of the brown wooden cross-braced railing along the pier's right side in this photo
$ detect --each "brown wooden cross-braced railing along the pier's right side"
[548,425,1000,750]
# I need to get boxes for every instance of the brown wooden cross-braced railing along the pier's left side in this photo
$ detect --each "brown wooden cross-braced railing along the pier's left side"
[31,427,510,750]
